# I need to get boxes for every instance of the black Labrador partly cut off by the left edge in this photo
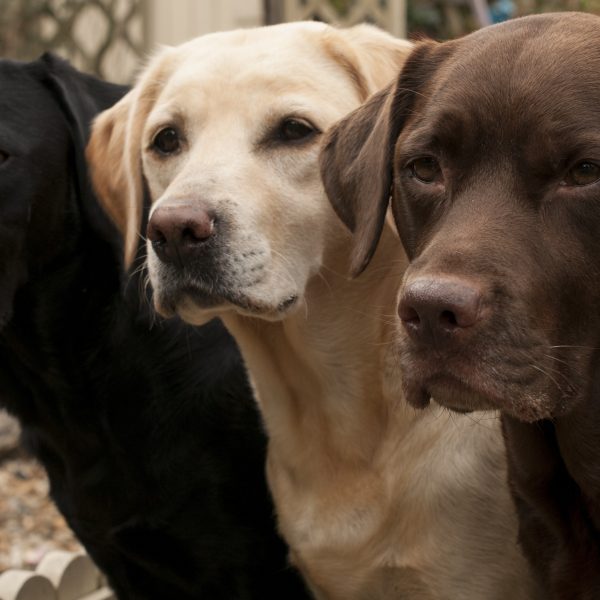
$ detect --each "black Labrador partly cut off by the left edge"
[0,55,307,600]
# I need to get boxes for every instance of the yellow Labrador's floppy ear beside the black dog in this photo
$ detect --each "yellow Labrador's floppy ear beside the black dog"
[86,48,174,267]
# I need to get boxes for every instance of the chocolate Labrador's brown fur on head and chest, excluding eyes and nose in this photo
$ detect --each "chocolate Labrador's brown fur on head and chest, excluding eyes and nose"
[322,13,600,600]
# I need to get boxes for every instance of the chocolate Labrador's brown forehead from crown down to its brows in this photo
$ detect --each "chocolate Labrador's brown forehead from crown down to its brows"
[401,14,600,159]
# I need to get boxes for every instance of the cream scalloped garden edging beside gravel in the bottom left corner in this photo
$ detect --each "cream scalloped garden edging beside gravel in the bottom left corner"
[0,550,117,600]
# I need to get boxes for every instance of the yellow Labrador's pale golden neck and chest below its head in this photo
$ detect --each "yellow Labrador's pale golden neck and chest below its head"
[223,220,524,600]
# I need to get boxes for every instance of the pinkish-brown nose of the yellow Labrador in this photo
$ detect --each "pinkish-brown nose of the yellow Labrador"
[146,205,216,267]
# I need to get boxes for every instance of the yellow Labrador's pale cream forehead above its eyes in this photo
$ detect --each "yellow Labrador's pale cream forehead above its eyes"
[156,22,358,121]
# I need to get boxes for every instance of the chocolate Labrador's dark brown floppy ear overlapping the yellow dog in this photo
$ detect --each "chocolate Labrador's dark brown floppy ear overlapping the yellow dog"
[320,41,450,276]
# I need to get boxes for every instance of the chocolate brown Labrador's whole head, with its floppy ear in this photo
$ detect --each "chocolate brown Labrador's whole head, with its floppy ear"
[321,13,600,421]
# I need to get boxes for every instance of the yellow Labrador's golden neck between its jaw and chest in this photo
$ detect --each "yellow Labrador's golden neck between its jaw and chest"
[223,220,413,476]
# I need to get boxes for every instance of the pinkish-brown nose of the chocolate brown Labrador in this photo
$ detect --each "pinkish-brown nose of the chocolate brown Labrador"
[398,277,483,345]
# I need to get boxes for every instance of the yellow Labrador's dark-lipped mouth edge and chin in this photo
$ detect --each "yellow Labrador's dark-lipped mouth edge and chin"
[154,286,300,325]
